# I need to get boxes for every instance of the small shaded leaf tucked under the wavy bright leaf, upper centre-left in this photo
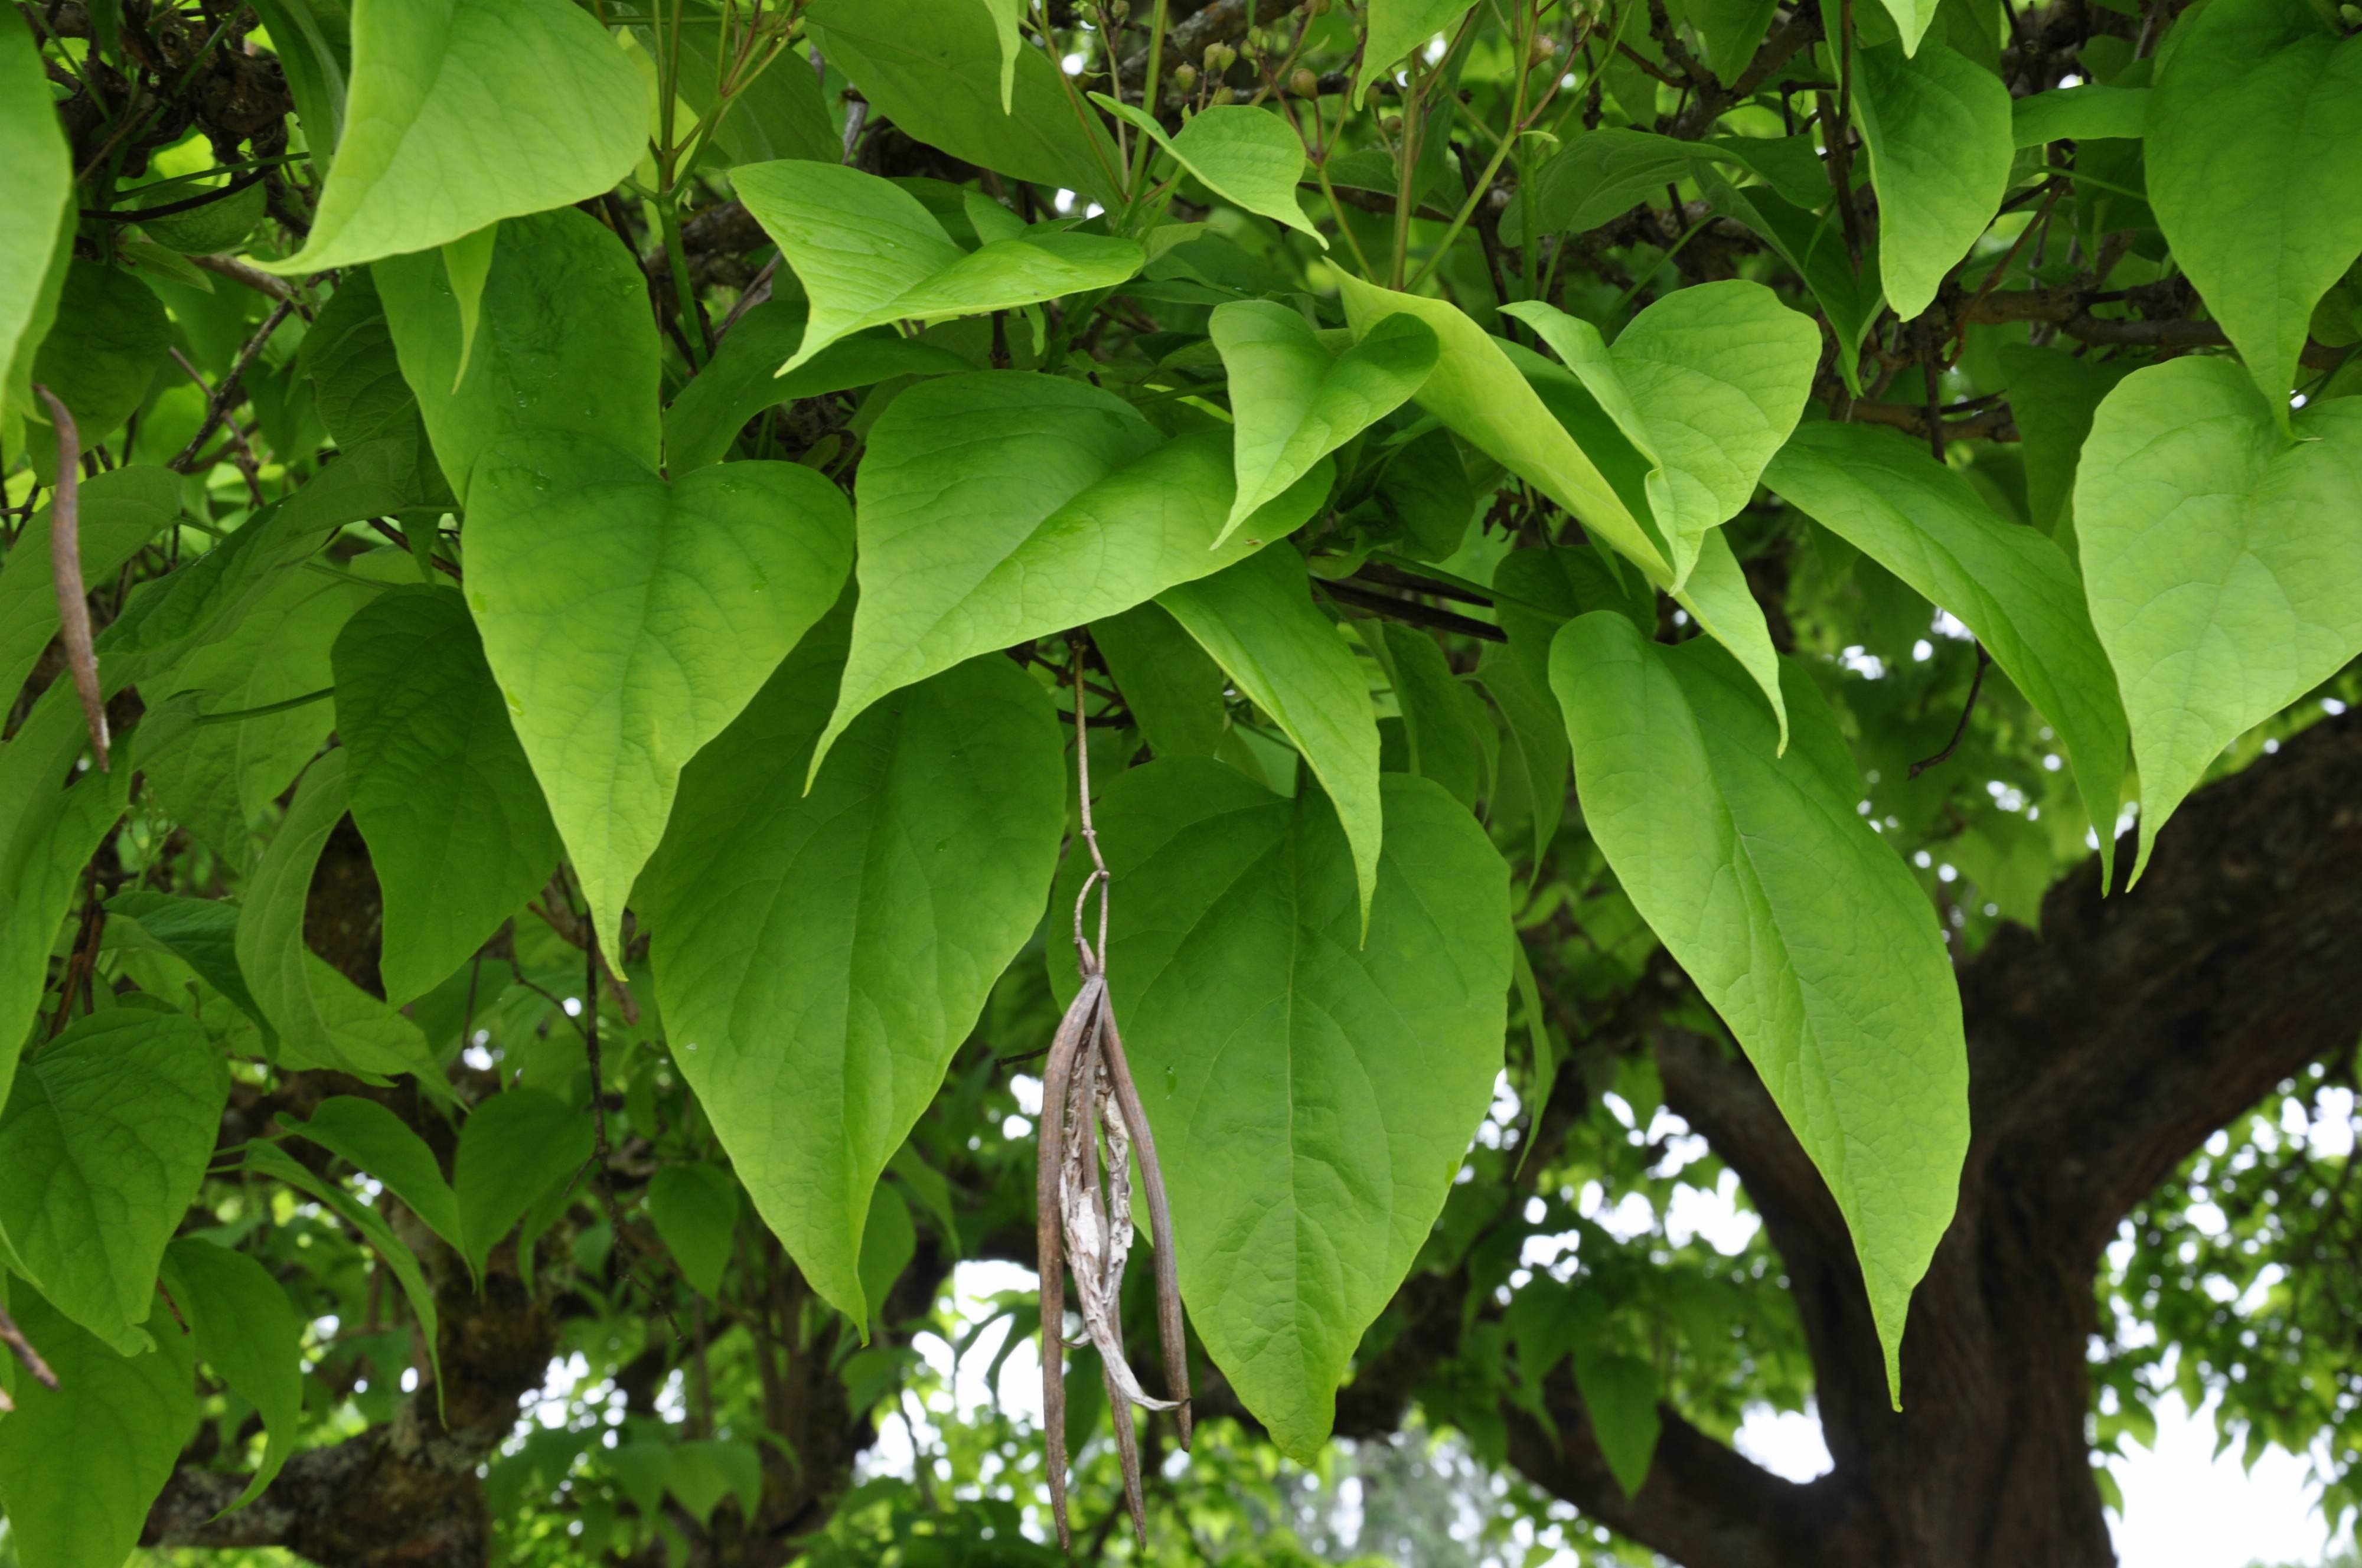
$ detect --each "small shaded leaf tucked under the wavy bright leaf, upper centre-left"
[664,300,976,479]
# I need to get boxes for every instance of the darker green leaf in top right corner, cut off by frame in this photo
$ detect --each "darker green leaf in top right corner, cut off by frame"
[2145,0,2362,413]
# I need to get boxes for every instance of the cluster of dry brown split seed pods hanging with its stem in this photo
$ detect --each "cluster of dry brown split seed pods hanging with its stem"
[1035,647,1190,1547]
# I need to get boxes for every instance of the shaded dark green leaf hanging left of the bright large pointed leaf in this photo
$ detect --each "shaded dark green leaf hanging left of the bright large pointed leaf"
[335,588,560,1006]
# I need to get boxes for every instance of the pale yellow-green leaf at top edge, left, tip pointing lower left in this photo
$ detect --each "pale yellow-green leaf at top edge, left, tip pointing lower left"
[257,0,654,272]
